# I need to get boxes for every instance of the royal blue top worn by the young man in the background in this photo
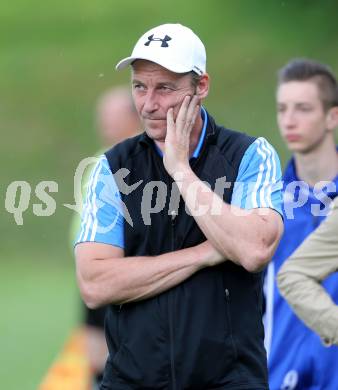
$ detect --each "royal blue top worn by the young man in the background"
[265,160,338,390]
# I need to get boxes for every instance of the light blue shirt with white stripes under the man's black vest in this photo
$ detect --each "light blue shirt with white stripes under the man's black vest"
[76,112,282,248]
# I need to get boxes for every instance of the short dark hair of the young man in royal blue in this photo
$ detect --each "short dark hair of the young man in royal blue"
[278,58,338,110]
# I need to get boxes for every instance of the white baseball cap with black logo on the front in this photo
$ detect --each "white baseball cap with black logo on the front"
[116,23,206,75]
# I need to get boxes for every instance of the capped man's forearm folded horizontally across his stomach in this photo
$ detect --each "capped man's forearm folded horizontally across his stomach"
[77,241,222,308]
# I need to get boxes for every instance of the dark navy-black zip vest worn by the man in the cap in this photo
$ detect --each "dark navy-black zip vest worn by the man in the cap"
[101,116,268,390]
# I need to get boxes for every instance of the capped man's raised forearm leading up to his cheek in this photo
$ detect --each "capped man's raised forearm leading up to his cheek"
[177,169,282,271]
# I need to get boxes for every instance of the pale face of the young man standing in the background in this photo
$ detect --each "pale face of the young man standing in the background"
[277,81,328,154]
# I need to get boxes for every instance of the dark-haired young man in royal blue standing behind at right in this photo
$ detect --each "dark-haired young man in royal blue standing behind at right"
[265,60,338,390]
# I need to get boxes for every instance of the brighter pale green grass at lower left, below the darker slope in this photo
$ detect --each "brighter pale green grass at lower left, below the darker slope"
[0,256,80,390]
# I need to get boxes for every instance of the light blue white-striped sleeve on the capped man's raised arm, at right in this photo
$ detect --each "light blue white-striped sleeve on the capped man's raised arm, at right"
[231,137,283,215]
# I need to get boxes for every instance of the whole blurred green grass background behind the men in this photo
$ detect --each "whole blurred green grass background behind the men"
[0,0,338,390]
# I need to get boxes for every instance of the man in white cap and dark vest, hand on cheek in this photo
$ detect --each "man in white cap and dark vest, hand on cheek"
[76,24,283,390]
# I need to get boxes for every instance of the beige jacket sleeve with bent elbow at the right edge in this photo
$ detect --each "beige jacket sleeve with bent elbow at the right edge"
[277,198,338,346]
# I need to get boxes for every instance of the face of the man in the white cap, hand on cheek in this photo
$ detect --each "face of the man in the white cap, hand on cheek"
[132,60,195,142]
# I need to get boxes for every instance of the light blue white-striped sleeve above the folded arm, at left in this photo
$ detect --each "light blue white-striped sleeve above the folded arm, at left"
[76,155,124,248]
